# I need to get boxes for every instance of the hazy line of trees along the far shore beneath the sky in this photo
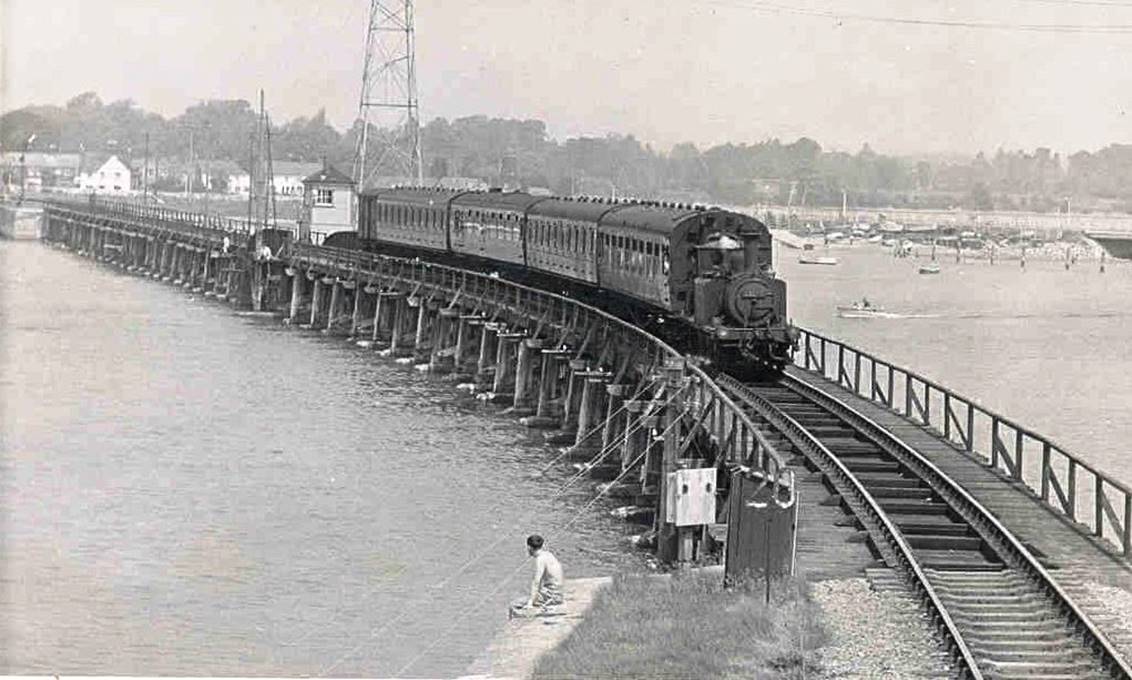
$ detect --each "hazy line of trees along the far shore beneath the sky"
[0,92,1132,212]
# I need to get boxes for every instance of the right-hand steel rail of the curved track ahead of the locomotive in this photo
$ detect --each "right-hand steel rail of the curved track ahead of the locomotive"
[780,373,1132,680]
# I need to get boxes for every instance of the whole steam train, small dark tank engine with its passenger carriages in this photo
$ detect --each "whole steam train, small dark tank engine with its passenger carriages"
[357,188,796,371]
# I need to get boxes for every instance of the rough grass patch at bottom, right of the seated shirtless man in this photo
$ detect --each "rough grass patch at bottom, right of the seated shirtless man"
[534,573,824,679]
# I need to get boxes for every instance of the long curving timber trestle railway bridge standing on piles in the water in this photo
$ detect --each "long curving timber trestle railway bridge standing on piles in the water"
[26,194,1132,678]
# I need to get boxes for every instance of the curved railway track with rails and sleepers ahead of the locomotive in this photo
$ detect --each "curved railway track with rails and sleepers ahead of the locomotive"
[718,373,1132,680]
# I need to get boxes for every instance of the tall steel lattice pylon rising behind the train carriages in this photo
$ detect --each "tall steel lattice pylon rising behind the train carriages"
[353,0,425,192]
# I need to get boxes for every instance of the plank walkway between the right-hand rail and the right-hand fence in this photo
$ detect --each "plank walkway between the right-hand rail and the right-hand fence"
[787,368,1132,646]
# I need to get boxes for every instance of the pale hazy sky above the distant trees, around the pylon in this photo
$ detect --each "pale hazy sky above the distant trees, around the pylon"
[0,0,1132,153]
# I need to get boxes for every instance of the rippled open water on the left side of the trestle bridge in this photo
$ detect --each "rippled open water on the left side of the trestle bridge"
[0,242,642,677]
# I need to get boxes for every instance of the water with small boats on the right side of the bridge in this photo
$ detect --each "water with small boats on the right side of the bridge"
[778,246,1132,484]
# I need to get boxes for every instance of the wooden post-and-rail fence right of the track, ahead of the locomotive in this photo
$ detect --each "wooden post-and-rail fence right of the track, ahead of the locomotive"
[795,328,1132,559]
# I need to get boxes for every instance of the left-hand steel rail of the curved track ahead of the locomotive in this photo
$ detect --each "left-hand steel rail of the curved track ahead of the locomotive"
[717,375,984,680]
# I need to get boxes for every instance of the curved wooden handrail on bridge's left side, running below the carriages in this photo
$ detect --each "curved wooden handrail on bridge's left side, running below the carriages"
[289,242,786,475]
